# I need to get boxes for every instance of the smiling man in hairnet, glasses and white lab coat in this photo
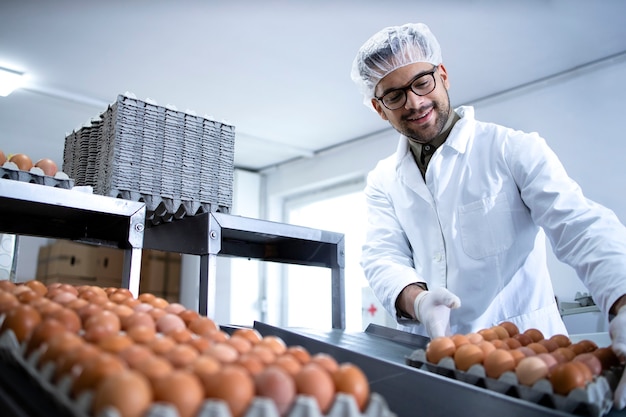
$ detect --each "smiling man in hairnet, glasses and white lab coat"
[352,24,626,408]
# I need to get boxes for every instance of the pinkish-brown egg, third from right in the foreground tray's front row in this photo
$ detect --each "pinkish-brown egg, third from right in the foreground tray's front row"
[254,365,296,416]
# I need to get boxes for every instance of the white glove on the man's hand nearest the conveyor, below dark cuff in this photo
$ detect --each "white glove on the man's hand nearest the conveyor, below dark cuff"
[413,287,458,338]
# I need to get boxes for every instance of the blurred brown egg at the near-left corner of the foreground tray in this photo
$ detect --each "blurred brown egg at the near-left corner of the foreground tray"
[92,370,153,417]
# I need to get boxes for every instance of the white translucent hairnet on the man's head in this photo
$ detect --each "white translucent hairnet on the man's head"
[351,23,442,106]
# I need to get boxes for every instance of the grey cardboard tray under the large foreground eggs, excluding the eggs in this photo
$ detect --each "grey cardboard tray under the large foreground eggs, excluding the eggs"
[0,326,397,417]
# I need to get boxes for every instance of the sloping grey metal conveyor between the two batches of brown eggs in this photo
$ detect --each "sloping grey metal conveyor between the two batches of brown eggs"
[254,322,626,417]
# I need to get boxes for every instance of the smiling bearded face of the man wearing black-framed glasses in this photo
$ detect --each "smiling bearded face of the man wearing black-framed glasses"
[372,62,450,143]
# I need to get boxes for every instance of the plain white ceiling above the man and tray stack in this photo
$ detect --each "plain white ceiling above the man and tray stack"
[0,0,626,171]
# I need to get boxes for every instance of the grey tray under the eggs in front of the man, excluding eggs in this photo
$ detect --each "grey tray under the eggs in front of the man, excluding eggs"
[406,349,621,417]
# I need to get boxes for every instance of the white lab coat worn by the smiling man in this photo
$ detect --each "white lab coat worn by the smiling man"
[361,107,626,336]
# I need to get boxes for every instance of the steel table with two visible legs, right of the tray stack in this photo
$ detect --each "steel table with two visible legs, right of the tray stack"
[144,213,345,329]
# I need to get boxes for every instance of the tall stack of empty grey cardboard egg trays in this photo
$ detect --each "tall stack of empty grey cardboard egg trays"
[63,94,235,224]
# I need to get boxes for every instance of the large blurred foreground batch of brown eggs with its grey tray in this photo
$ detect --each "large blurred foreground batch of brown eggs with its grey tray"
[0,280,395,417]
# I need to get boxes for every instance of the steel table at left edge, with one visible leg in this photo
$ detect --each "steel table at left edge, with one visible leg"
[0,179,146,296]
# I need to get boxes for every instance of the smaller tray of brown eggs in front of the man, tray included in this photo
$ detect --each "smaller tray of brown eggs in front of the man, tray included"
[406,322,623,417]
